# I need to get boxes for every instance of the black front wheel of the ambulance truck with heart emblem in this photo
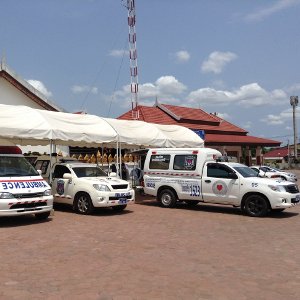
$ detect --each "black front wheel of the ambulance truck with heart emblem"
[244,195,270,217]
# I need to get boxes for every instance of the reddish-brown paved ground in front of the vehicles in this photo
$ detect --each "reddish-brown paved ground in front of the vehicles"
[0,172,300,300]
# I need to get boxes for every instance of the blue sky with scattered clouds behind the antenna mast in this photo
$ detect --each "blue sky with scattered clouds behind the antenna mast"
[0,0,300,144]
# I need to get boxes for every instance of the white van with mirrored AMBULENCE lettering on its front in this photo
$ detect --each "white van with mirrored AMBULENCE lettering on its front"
[0,146,53,220]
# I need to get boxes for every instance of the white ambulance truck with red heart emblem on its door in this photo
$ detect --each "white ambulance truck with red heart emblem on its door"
[144,148,300,217]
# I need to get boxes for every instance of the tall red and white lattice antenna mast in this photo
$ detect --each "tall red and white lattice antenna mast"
[122,0,139,120]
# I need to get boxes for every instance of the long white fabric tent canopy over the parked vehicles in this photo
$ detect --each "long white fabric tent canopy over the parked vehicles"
[0,104,204,148]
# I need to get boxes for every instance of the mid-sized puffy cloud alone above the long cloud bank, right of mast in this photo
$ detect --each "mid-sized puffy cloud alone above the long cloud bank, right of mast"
[201,51,238,74]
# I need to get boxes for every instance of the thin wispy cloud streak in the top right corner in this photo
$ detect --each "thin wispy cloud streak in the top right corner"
[245,0,300,22]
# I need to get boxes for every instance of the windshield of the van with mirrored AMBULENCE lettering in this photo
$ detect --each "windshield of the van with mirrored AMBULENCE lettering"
[0,155,39,177]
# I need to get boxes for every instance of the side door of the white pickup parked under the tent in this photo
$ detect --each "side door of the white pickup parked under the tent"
[52,165,71,203]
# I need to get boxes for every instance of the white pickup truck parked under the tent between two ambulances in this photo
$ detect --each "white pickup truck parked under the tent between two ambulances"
[52,161,135,214]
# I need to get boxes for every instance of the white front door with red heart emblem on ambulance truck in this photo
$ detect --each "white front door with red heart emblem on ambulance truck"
[202,163,240,205]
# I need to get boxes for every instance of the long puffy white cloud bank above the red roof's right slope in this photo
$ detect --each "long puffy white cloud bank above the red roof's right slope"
[187,83,288,107]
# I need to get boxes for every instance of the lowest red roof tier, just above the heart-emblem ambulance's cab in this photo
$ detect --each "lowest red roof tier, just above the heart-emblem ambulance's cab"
[205,134,280,147]
